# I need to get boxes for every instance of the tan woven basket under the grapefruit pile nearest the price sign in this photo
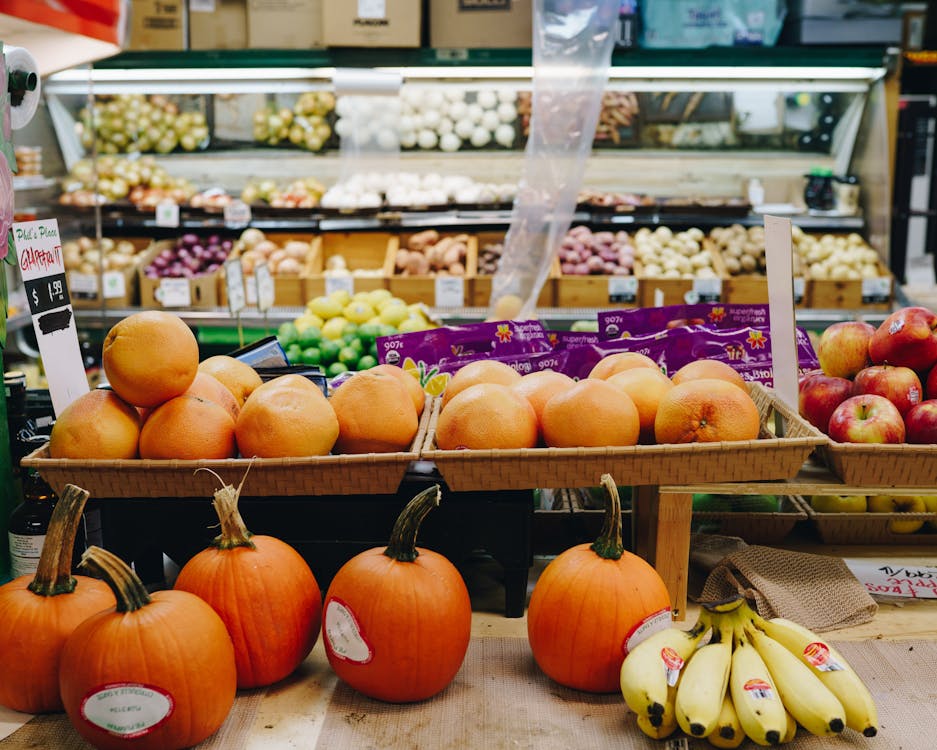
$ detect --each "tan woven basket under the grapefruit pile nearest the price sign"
[21,397,431,498]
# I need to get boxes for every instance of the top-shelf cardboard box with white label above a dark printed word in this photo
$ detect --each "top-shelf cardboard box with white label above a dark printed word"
[322,0,422,47]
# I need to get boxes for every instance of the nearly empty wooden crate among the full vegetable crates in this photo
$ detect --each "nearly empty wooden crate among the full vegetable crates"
[303,232,397,300]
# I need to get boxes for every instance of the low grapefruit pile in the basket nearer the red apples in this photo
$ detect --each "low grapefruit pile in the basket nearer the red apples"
[436,352,760,450]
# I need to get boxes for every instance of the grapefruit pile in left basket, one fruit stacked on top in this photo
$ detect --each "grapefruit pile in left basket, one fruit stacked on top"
[49,310,424,460]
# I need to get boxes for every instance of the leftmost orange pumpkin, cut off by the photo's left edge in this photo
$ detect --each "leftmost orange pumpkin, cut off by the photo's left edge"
[0,484,114,714]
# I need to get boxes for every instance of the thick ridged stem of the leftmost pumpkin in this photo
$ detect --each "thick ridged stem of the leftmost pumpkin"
[29,484,88,596]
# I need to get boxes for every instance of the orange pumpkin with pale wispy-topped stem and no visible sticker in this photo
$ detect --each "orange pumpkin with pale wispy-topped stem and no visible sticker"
[175,475,322,688]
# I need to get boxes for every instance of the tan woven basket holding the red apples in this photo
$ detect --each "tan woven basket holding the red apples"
[817,441,937,489]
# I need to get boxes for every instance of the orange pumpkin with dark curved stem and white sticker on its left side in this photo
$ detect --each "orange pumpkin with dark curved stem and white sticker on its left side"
[322,485,472,703]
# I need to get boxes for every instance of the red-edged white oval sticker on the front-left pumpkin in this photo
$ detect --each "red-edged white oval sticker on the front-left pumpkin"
[81,682,174,740]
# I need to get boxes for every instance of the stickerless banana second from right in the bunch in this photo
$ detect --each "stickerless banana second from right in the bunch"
[748,628,846,737]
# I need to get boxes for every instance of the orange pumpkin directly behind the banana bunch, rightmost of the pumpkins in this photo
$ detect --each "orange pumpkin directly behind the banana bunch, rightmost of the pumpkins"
[527,474,671,693]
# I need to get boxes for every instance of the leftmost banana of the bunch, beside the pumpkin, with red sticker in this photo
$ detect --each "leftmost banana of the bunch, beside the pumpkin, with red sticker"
[621,613,709,722]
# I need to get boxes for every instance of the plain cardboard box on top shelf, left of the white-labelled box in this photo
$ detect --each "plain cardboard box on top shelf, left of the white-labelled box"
[247,0,324,49]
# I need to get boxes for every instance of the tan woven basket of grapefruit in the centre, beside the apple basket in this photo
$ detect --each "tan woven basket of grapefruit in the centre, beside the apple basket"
[421,383,826,491]
